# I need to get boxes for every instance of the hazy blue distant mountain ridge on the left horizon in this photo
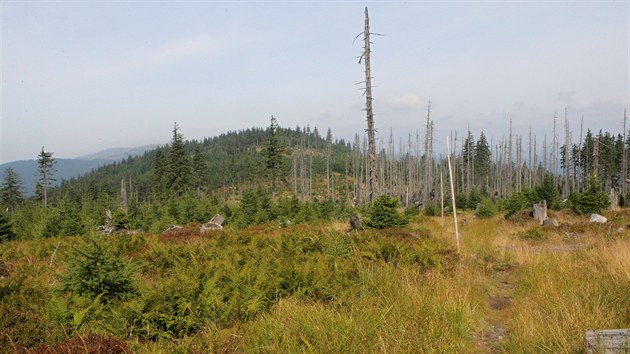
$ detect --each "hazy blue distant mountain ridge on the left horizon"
[0,144,159,196]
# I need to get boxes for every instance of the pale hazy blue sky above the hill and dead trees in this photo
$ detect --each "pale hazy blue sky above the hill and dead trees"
[0,0,630,163]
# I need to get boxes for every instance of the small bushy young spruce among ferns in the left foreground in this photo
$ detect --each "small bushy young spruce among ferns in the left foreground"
[58,238,138,302]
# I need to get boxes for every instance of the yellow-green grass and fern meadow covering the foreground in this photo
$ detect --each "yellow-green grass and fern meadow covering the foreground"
[0,212,630,353]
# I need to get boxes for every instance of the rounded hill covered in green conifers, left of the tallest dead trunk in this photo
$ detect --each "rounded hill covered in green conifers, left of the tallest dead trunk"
[51,127,350,205]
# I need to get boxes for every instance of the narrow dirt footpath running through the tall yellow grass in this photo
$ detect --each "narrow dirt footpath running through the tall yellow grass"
[475,266,516,353]
